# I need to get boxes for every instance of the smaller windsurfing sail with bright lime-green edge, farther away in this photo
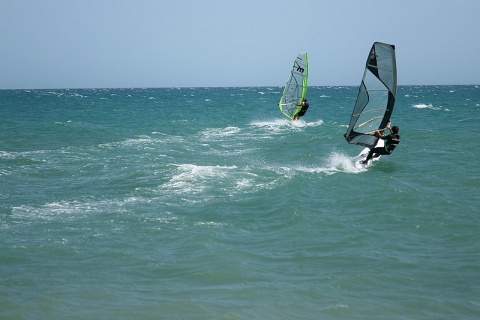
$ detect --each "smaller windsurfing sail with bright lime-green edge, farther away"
[278,53,308,119]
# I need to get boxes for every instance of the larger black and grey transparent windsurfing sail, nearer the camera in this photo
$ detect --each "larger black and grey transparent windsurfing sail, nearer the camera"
[344,42,397,148]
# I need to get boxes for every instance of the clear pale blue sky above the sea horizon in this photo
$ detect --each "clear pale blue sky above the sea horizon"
[0,0,480,89]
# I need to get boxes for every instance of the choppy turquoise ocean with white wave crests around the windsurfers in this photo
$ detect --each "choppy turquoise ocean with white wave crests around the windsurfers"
[0,85,480,320]
